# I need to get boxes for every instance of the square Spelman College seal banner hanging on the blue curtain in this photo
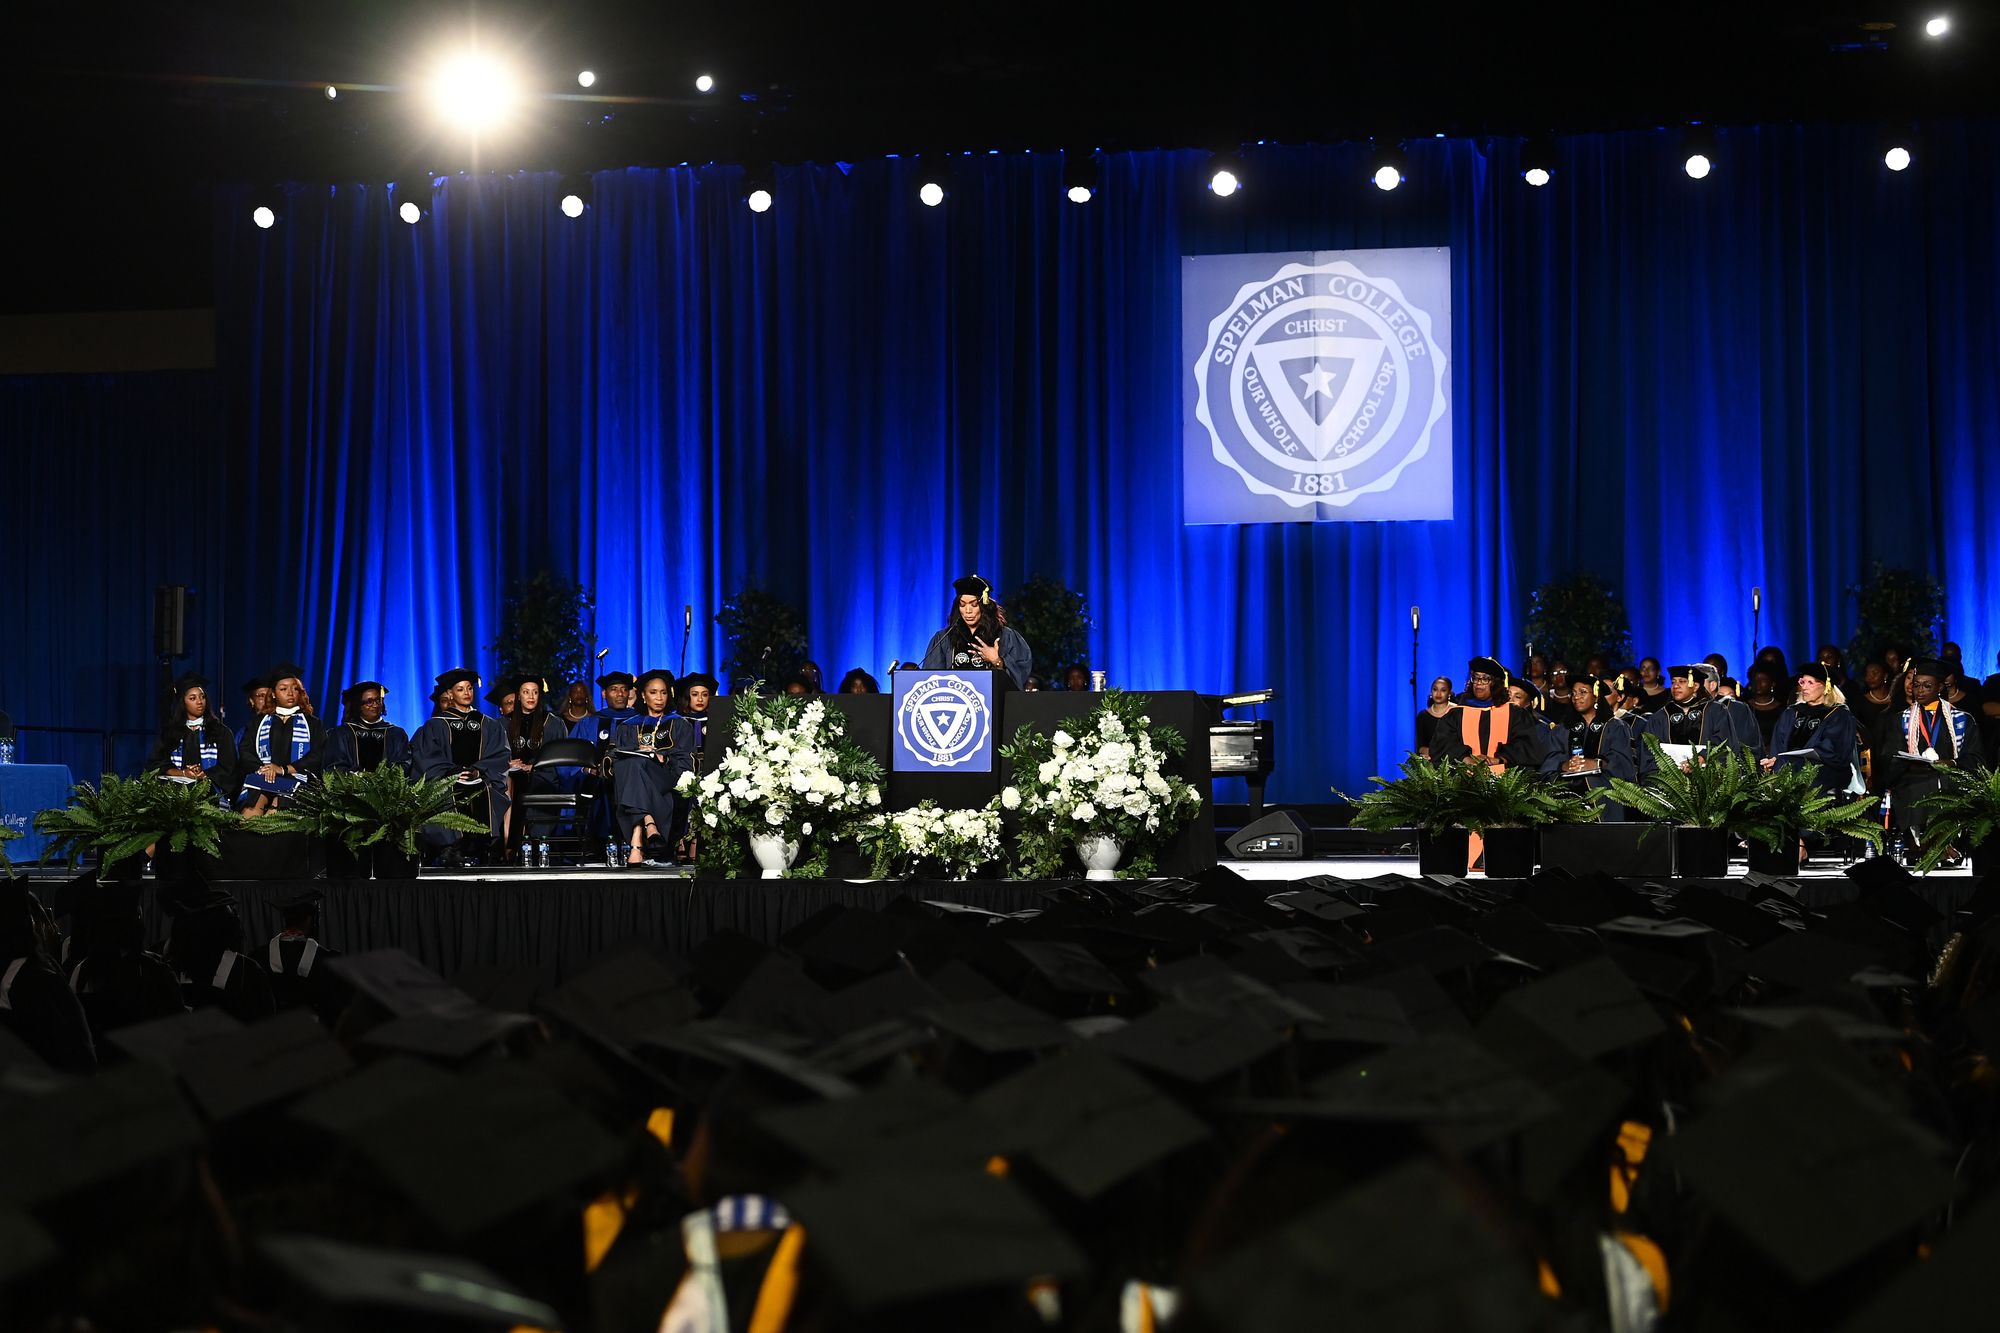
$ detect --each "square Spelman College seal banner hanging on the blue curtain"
[1180,248,1452,522]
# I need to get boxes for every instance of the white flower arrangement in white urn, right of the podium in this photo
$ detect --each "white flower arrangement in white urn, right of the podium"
[1000,691,1202,879]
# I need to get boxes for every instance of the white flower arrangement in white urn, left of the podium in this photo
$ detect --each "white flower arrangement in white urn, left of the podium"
[676,691,882,879]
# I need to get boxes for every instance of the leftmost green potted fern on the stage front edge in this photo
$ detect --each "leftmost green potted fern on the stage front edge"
[34,773,242,879]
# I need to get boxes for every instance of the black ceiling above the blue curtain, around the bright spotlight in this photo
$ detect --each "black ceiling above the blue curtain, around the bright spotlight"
[0,0,2000,310]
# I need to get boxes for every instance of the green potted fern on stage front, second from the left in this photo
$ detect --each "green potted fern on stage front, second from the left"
[250,765,486,879]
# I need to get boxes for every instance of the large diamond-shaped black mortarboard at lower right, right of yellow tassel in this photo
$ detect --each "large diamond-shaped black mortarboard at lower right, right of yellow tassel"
[1662,1063,1954,1287]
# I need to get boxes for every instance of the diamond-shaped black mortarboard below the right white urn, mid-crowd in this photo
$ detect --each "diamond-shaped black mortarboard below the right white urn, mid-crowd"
[972,1047,1210,1199]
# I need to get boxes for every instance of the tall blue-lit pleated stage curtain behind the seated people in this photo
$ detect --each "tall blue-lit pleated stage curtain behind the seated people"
[4,124,2000,801]
